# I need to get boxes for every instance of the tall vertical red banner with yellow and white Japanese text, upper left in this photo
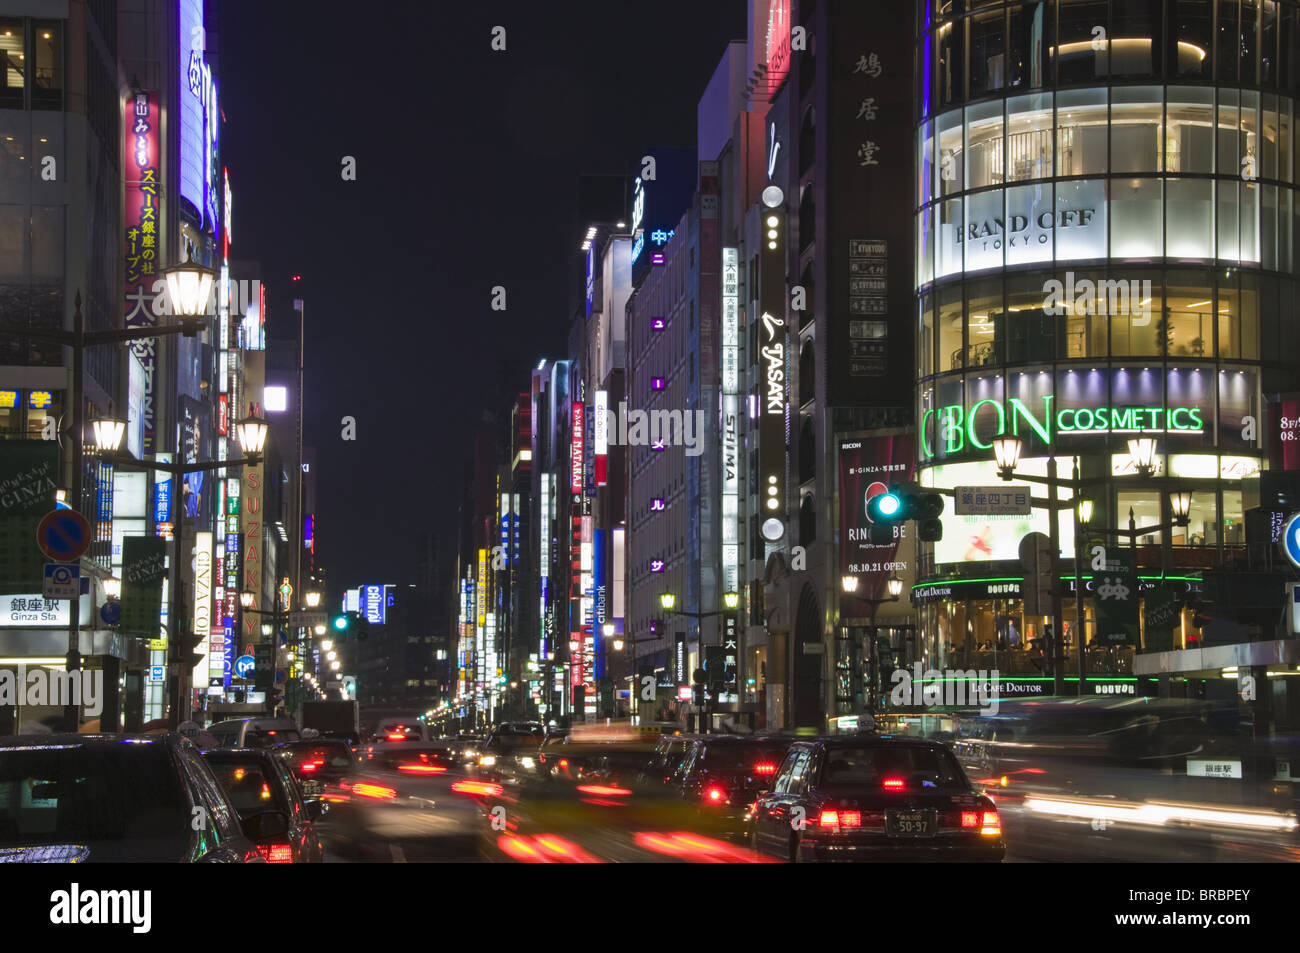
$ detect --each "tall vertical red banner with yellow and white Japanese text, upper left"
[122,90,161,454]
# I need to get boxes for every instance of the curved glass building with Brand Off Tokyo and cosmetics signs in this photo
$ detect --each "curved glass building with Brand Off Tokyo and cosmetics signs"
[914,0,1300,694]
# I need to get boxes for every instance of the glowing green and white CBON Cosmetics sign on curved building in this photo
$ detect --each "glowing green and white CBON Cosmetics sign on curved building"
[920,394,1205,460]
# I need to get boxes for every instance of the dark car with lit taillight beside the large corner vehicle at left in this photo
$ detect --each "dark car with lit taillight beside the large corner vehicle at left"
[203,748,325,863]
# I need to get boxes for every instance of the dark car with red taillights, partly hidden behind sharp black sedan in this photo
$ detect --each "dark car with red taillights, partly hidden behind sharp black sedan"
[668,735,790,833]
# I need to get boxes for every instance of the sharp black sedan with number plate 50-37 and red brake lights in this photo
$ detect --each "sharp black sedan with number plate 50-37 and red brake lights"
[746,735,1006,862]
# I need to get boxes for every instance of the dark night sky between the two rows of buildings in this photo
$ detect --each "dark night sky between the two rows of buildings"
[220,0,746,595]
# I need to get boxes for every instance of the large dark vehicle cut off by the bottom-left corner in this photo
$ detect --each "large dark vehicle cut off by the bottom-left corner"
[0,732,265,863]
